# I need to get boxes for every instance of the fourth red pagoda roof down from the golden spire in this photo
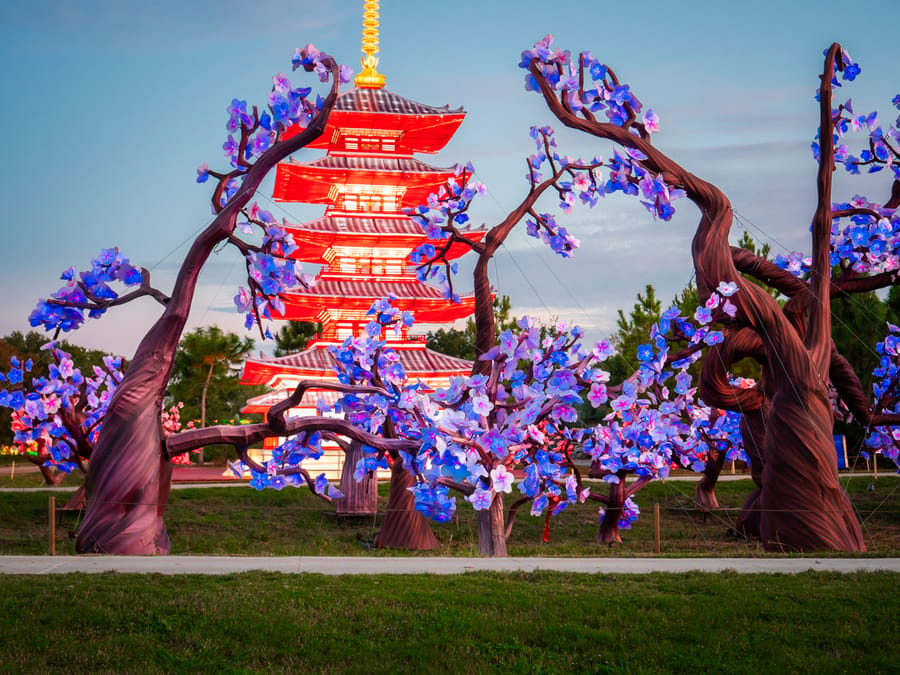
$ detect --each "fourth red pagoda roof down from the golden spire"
[280,276,475,323]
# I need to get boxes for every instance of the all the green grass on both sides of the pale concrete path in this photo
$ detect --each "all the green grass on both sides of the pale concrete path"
[0,468,900,674]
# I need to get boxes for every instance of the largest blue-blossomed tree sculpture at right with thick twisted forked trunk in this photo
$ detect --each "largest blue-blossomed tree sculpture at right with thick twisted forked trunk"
[521,37,900,551]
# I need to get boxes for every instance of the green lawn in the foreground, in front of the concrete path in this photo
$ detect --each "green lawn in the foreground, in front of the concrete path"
[0,572,900,675]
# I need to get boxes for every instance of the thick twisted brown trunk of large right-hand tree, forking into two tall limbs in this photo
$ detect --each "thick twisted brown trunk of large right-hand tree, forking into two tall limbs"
[531,44,865,551]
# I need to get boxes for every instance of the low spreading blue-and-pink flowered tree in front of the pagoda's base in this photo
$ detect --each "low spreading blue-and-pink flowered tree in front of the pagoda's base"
[189,300,606,557]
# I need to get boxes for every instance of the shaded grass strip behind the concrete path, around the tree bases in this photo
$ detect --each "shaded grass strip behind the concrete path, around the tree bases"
[0,476,900,556]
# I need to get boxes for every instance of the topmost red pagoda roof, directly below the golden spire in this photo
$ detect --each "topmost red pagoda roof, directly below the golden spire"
[284,88,466,154]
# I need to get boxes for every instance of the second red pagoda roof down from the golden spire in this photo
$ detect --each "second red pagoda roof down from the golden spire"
[272,155,456,207]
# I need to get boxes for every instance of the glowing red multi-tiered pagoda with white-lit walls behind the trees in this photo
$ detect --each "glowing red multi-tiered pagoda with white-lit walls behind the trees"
[236,3,485,496]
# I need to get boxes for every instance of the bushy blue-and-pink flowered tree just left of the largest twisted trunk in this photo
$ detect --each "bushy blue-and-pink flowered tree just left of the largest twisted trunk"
[584,304,743,544]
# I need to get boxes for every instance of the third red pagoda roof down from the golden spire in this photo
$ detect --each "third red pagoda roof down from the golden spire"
[287,214,486,263]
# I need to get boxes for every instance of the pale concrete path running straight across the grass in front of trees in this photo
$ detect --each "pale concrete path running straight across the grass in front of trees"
[0,556,900,574]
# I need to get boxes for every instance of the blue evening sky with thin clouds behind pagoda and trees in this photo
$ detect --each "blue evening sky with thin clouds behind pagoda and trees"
[0,0,900,356]
